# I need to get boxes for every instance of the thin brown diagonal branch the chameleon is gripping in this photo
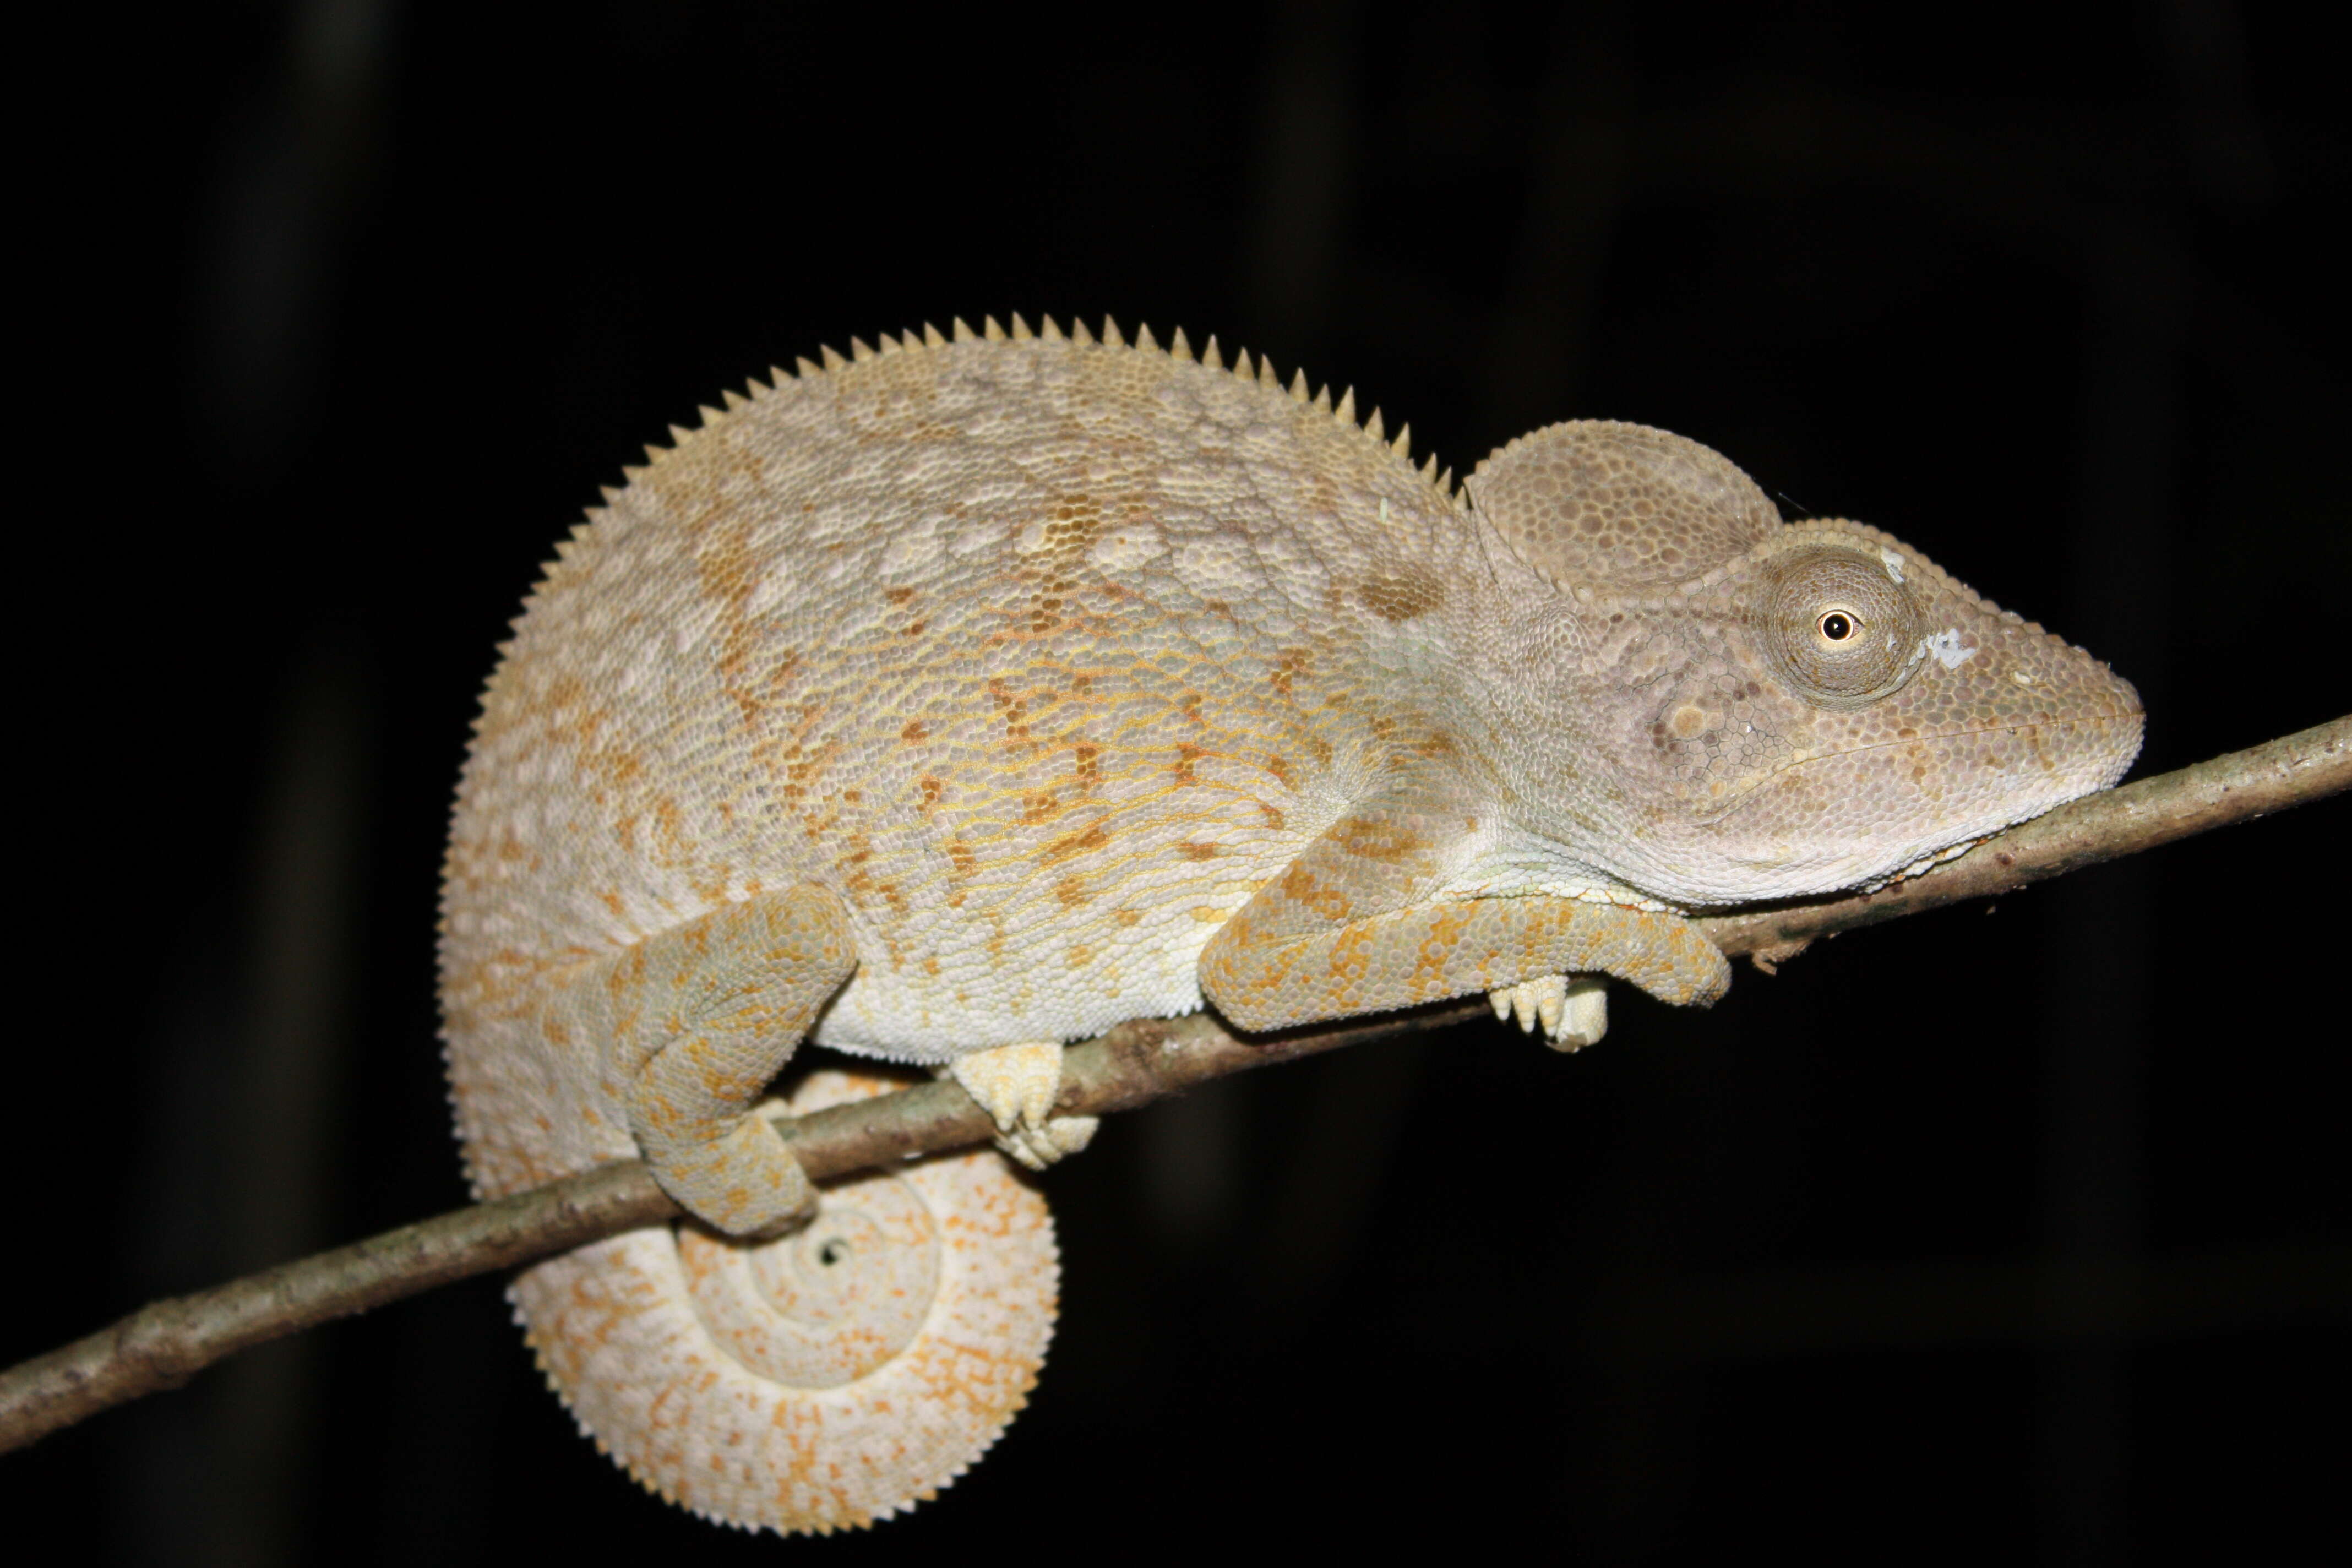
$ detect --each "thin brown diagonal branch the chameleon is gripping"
[0,717,2352,1453]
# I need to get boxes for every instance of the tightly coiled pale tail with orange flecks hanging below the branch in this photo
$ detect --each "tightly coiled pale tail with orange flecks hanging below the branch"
[510,1070,1061,1535]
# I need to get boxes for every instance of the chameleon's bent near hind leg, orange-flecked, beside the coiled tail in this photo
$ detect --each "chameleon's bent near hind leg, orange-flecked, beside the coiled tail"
[609,886,858,1237]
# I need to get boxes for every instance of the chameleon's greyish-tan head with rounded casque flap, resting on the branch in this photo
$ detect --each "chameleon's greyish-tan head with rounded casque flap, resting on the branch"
[1470,423,2143,905]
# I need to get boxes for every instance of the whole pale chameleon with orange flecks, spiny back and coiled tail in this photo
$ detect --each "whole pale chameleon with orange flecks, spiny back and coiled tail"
[442,317,2141,1531]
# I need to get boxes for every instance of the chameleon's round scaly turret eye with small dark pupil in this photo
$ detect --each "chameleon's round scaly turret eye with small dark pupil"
[1757,546,1919,707]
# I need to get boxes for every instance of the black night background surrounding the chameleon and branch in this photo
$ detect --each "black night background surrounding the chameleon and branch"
[0,0,2352,1563]
